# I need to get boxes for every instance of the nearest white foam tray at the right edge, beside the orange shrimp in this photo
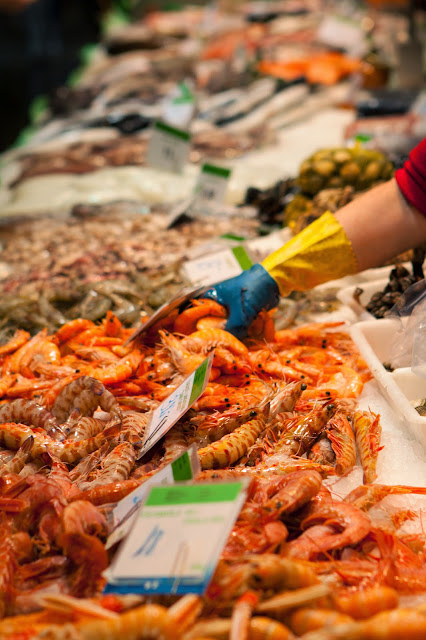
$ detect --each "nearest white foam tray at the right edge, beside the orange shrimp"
[350,319,426,445]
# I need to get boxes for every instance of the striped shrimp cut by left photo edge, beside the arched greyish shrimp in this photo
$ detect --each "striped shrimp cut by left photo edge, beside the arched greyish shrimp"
[0,398,65,440]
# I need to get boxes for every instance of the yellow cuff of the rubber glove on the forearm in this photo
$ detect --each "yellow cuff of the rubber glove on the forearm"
[262,211,358,296]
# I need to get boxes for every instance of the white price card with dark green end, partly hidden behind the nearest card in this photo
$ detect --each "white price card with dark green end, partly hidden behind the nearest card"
[105,444,201,549]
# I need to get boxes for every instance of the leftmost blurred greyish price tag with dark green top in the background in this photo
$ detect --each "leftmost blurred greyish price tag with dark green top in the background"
[147,121,191,173]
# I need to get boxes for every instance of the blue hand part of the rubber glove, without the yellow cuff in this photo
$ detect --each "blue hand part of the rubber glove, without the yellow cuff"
[203,264,280,339]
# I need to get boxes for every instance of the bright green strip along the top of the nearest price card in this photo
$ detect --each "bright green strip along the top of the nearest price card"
[145,482,242,507]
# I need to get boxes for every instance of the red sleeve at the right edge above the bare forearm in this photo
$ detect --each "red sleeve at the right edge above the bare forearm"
[395,138,426,216]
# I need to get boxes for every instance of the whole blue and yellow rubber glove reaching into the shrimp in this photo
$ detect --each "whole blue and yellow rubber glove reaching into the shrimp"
[204,212,358,338]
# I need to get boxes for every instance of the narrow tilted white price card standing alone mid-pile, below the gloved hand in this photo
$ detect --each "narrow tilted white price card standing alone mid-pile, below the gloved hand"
[138,353,213,458]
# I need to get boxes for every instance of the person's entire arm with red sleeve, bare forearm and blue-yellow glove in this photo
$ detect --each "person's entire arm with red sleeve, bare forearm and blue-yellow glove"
[207,139,426,337]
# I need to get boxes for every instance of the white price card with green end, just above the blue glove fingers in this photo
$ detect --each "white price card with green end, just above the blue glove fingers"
[182,246,253,286]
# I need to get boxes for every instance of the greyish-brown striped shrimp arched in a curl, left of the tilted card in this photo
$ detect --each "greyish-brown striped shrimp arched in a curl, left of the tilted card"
[52,376,121,422]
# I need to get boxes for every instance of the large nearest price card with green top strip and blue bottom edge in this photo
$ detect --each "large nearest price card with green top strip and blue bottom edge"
[105,480,247,595]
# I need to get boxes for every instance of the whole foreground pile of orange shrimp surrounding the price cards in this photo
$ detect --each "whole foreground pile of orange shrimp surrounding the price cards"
[0,300,426,640]
